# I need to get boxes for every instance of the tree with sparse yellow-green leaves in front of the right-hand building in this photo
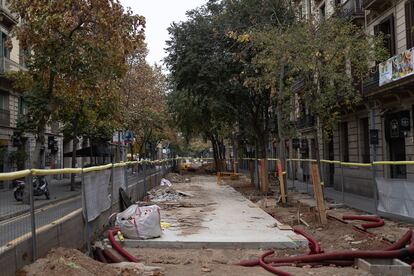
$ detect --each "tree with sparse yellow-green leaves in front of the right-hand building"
[255,16,384,165]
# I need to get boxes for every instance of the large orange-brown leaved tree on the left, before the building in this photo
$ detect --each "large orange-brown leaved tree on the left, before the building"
[10,0,145,188]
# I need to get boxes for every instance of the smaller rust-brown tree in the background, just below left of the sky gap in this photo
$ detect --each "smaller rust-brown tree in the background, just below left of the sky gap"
[121,49,172,157]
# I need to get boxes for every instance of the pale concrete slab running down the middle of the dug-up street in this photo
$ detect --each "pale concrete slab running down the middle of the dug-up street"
[124,176,307,249]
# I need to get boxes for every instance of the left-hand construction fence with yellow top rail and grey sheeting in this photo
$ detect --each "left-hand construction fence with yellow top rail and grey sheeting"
[0,158,176,276]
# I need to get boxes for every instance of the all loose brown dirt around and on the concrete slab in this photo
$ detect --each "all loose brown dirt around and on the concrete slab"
[18,174,414,276]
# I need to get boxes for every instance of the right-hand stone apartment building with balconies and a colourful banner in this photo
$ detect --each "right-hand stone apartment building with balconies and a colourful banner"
[289,0,414,197]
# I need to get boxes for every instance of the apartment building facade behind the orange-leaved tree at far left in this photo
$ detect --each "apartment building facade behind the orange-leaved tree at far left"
[0,0,63,188]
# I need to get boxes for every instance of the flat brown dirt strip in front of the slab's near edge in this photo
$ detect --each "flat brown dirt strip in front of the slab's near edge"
[128,248,370,276]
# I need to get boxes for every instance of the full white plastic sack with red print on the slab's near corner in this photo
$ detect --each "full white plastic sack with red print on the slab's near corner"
[116,204,162,240]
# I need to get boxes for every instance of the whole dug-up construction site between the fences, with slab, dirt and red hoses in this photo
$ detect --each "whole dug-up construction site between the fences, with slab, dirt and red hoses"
[4,159,414,276]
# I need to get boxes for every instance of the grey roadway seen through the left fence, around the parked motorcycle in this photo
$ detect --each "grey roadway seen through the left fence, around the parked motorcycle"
[0,178,81,221]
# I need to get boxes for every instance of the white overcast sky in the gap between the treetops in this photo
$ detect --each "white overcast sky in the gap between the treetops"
[121,0,206,64]
